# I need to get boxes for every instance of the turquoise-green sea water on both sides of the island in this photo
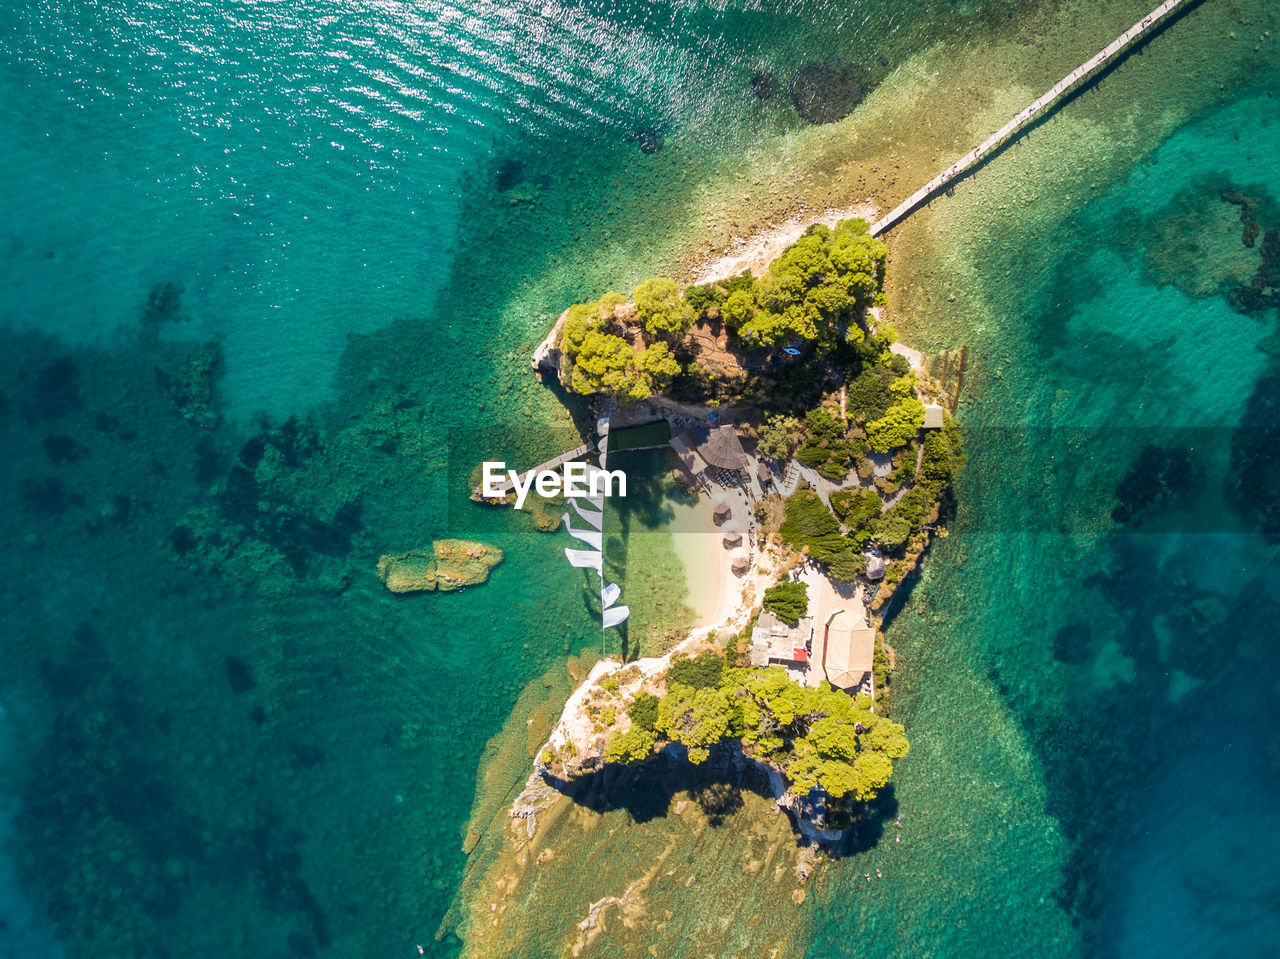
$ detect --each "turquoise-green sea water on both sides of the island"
[0,0,1280,956]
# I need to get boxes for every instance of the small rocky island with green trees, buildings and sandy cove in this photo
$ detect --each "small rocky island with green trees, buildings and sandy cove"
[512,218,964,849]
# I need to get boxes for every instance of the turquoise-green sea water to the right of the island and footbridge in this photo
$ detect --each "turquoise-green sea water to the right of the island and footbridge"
[810,82,1280,956]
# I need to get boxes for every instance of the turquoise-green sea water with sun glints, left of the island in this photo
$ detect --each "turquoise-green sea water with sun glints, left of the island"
[0,0,1008,956]
